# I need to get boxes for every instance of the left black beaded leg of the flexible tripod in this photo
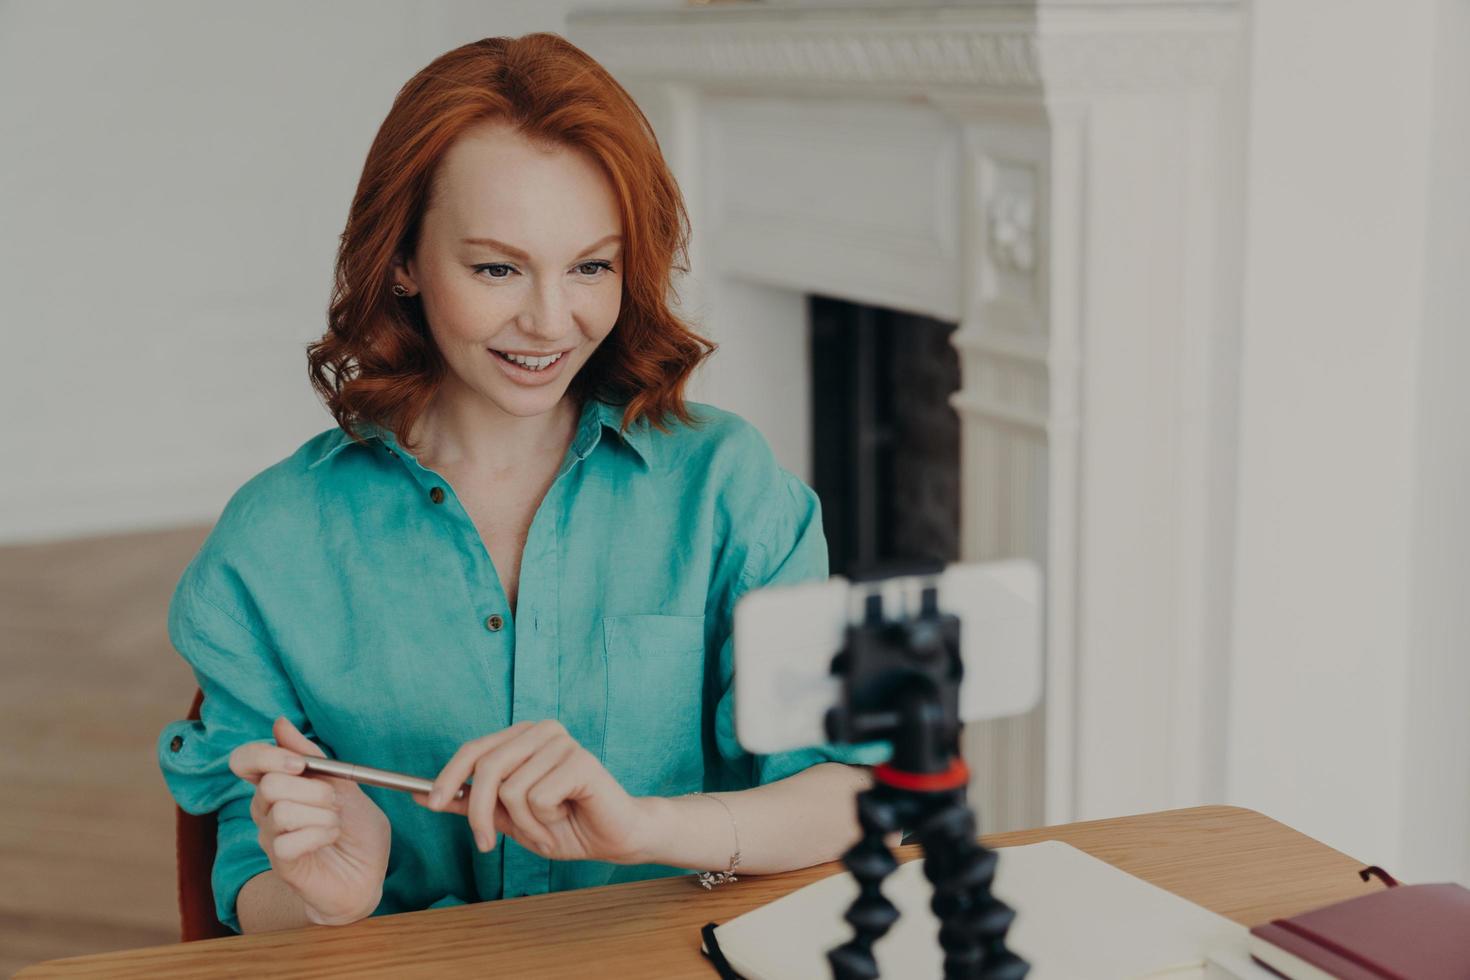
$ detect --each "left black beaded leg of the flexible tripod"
[828,785,910,980]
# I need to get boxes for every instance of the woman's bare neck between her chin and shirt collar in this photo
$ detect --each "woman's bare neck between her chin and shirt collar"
[410,388,581,470]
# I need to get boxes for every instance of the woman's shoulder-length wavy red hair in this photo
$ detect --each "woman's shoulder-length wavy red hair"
[307,34,716,455]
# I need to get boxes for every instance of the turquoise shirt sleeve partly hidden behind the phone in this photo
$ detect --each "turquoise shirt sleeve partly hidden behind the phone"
[714,470,892,785]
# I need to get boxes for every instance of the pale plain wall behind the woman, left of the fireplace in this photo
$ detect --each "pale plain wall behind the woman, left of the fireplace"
[0,0,672,544]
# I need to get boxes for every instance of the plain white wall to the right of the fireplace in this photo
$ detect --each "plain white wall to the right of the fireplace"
[1229,0,1470,880]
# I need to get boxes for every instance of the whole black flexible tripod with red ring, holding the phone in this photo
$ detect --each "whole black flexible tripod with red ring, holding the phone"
[826,567,1030,980]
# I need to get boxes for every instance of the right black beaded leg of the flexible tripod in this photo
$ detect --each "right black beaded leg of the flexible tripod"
[919,790,1030,980]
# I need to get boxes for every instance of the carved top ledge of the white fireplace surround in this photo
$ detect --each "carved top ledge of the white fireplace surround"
[569,0,1239,96]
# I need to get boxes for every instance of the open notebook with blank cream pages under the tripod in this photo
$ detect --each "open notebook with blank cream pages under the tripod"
[702,840,1245,980]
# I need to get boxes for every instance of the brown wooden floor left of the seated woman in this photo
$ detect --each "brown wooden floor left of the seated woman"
[0,527,209,977]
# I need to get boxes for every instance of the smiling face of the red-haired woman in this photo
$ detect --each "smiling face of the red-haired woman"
[394,122,623,417]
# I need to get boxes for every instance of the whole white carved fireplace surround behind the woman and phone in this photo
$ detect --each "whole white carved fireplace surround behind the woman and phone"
[567,0,1241,829]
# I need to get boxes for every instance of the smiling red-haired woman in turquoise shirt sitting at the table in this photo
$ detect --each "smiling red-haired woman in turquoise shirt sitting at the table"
[159,34,886,932]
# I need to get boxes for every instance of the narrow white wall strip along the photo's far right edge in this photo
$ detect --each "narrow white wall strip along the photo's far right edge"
[1398,0,1470,884]
